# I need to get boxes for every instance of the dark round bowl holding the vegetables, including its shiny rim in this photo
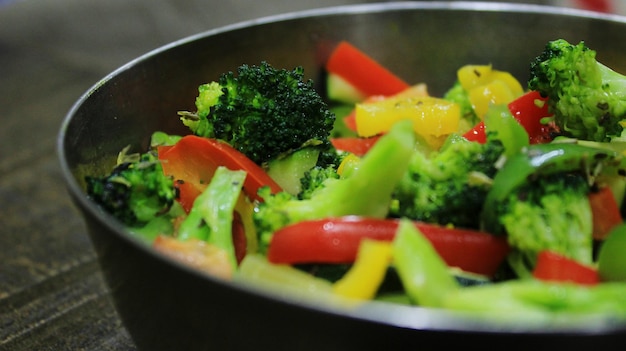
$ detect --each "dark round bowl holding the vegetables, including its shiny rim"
[58,2,626,351]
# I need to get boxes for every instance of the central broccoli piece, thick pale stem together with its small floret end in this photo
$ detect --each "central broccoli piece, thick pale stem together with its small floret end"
[254,121,415,250]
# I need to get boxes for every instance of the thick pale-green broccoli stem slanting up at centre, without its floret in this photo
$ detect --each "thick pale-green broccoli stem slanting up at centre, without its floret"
[288,121,415,223]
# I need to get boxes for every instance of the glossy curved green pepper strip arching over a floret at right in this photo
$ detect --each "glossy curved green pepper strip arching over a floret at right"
[481,143,626,234]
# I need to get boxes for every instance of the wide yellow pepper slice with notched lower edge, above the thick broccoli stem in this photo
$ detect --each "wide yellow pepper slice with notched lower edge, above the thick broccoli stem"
[355,96,461,142]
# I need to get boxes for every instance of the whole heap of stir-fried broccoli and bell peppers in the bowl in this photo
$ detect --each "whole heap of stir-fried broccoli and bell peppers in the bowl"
[87,40,626,320]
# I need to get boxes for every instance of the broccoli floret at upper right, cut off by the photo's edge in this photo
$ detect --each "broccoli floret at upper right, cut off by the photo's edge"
[528,39,626,142]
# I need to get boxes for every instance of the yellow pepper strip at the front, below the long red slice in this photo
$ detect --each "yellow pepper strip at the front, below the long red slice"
[333,239,392,300]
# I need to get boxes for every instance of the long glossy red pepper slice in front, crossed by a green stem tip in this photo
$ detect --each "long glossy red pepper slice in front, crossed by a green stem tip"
[267,216,509,276]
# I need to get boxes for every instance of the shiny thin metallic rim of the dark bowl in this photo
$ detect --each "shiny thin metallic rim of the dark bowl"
[56,1,626,335]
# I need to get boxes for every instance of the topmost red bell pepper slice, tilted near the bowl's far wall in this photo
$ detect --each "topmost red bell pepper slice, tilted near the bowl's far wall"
[326,41,409,96]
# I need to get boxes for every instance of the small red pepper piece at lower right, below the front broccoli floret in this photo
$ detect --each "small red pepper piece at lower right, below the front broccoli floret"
[533,251,600,285]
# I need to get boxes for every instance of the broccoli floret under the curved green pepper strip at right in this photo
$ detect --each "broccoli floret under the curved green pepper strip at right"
[499,173,592,273]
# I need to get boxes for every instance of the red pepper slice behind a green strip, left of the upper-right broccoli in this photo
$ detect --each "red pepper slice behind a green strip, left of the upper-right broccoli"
[463,91,556,144]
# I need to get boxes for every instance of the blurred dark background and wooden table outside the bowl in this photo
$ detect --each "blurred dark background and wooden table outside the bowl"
[0,0,626,350]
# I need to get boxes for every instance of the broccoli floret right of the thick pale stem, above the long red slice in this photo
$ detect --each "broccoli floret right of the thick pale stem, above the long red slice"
[394,138,504,228]
